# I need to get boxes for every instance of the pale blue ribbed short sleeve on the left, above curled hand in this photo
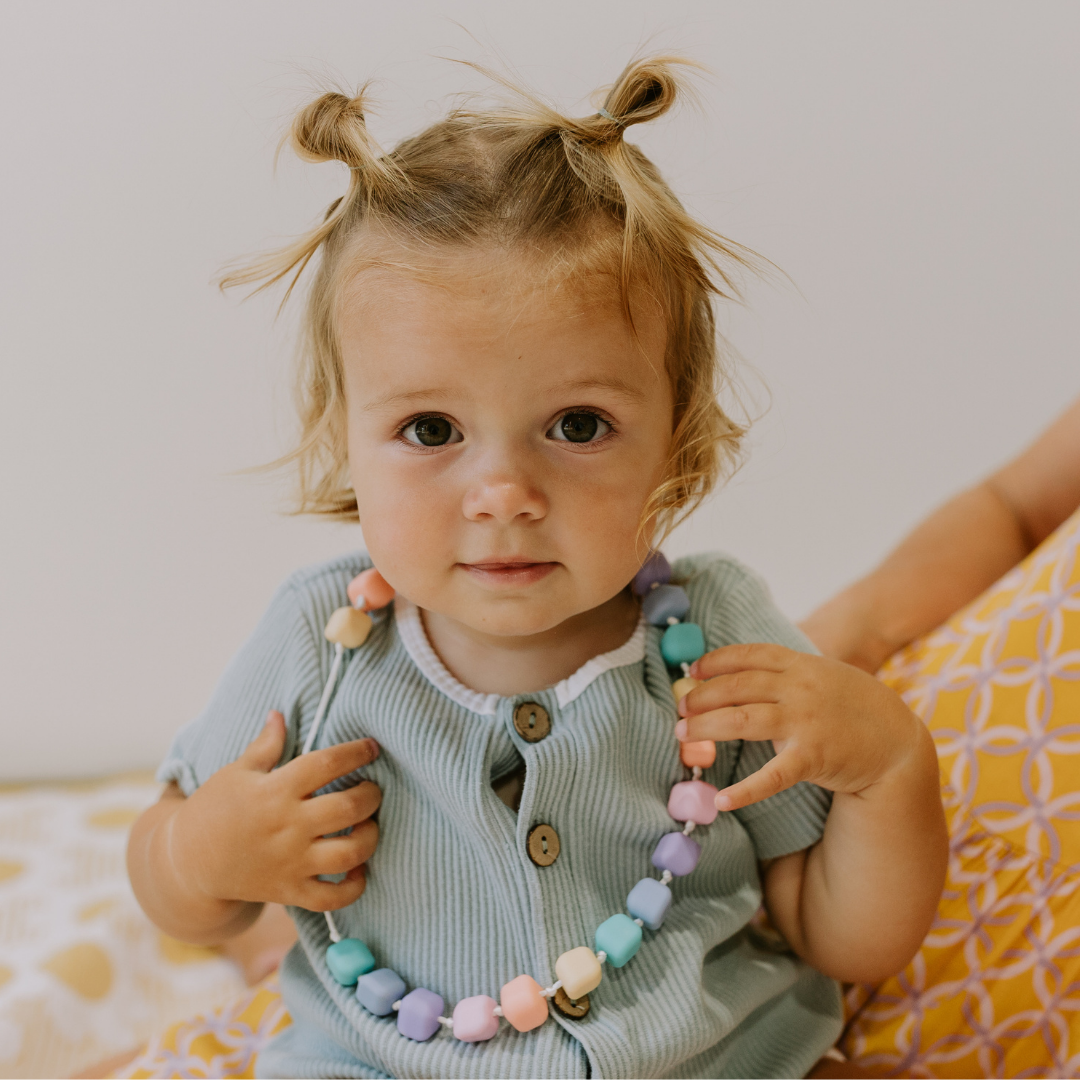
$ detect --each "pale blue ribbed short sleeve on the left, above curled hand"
[158,581,324,795]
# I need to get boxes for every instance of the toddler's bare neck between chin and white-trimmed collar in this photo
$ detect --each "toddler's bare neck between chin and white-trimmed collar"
[420,589,639,697]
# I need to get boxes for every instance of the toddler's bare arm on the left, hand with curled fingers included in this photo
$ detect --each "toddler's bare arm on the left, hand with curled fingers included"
[127,713,381,945]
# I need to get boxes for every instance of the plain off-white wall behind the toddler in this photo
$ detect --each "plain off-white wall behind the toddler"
[0,0,1080,779]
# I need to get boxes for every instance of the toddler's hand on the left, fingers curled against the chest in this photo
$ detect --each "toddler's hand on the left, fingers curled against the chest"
[167,712,382,912]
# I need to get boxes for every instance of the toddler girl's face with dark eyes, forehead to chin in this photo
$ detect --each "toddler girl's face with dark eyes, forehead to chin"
[340,252,672,636]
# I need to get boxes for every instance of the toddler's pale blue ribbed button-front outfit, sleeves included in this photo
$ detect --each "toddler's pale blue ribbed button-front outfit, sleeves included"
[159,555,841,1077]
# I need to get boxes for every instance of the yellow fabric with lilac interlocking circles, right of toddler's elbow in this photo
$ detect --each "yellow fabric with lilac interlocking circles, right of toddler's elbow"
[842,512,1080,1077]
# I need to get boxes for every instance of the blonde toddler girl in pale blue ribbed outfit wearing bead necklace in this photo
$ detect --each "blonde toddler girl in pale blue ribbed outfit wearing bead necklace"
[130,59,945,1077]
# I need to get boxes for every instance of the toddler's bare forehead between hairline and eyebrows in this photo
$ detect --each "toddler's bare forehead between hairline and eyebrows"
[335,248,665,397]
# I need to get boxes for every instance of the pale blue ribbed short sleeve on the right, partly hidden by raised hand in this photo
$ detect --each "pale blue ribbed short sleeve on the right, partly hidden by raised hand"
[688,556,833,859]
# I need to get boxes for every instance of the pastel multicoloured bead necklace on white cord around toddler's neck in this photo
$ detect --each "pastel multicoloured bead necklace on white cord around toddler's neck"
[301,552,717,1042]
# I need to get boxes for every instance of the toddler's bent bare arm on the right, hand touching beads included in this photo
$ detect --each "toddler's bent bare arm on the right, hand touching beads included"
[677,645,948,983]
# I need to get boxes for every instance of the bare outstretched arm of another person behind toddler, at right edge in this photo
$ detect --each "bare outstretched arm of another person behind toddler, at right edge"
[802,399,1080,672]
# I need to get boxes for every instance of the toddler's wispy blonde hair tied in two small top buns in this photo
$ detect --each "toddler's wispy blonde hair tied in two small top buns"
[221,56,764,542]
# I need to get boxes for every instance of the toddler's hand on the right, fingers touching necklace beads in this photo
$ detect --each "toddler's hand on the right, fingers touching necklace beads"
[675,645,924,810]
